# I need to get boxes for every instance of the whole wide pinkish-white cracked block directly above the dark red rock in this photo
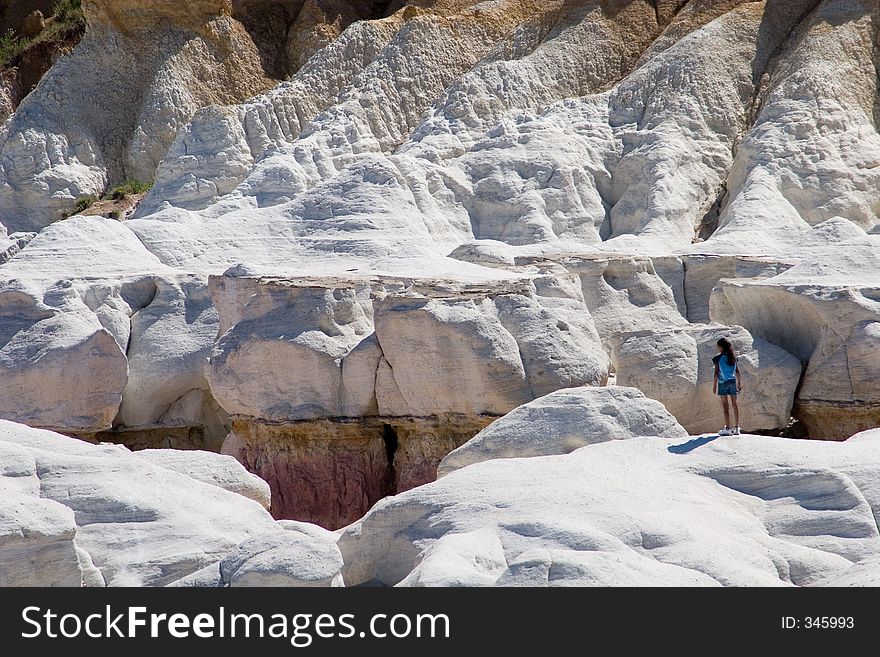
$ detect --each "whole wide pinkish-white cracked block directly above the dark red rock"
[208,267,608,422]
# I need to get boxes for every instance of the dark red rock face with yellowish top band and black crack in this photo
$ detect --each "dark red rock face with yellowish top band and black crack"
[223,416,494,529]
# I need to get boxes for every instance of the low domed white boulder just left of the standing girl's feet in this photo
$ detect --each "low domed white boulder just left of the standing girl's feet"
[437,386,688,477]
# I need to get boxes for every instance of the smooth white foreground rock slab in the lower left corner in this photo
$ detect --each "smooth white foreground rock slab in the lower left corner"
[0,421,341,586]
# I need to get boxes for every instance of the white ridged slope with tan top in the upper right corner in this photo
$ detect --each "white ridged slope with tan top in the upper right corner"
[717,0,880,253]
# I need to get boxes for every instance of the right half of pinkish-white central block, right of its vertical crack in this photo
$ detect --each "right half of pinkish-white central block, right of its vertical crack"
[375,294,608,416]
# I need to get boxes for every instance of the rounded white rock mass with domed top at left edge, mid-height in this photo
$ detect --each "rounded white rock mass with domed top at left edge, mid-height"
[0,217,229,440]
